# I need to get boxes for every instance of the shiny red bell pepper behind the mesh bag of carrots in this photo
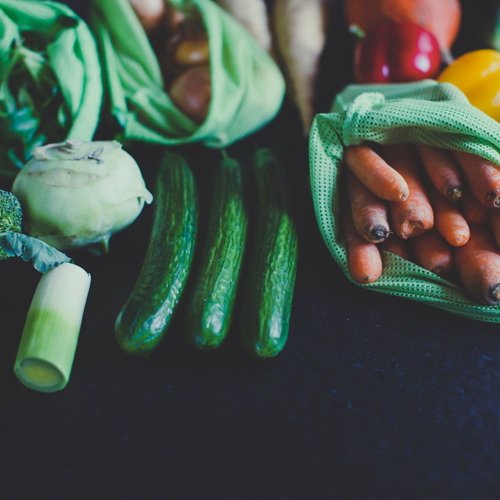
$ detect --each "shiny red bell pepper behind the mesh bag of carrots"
[354,21,441,83]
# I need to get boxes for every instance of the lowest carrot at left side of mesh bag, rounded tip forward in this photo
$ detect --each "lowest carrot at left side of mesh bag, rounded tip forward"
[341,195,382,283]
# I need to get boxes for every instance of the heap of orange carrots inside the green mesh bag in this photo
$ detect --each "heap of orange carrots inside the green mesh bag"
[341,145,500,305]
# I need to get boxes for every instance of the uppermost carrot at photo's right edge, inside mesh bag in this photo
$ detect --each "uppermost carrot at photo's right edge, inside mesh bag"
[454,151,500,208]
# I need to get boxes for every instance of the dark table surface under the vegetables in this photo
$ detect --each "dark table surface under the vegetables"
[0,2,500,499]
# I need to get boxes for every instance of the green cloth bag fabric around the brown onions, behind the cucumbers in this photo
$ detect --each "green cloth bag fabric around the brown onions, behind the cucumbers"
[91,0,285,148]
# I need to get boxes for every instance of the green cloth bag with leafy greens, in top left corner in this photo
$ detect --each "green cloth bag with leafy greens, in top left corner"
[0,0,103,175]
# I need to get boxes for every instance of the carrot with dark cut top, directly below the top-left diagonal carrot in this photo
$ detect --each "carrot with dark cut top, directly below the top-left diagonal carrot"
[346,171,391,243]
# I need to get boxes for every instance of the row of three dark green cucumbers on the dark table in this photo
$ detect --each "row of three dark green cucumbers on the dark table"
[115,149,297,358]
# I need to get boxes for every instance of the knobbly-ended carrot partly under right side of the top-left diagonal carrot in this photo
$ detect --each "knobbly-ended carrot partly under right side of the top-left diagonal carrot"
[382,146,434,240]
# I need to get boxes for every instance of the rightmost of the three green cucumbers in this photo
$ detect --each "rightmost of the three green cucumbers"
[238,149,298,358]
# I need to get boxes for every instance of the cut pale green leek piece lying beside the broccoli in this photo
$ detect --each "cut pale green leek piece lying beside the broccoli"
[14,263,90,392]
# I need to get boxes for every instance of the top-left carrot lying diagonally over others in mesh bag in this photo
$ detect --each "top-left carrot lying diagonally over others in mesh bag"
[344,146,409,201]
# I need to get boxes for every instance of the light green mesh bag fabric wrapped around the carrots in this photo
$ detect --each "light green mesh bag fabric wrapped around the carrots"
[309,80,500,322]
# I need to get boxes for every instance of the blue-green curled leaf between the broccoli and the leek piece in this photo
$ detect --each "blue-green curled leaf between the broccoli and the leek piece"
[0,231,72,273]
